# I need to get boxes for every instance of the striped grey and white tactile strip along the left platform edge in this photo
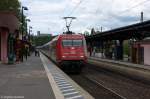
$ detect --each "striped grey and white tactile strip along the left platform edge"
[41,54,84,99]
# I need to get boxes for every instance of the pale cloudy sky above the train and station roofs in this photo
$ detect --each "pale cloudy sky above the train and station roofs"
[20,0,150,35]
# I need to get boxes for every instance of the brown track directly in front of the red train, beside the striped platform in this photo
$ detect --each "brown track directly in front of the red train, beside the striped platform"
[70,75,124,99]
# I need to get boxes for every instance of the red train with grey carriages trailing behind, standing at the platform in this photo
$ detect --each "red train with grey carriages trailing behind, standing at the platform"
[42,34,87,72]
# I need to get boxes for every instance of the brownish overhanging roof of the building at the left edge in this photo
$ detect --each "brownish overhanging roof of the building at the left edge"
[0,11,19,33]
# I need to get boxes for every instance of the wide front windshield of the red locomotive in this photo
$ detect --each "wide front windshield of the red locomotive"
[62,40,83,46]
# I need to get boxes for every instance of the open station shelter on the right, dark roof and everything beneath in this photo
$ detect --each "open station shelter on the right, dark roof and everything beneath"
[86,20,150,65]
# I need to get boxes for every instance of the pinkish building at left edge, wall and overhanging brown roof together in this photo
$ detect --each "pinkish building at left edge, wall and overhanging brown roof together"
[0,11,19,63]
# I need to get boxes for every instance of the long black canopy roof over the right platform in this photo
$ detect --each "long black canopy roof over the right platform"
[86,20,150,41]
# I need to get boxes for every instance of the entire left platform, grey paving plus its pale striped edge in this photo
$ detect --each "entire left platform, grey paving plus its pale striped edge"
[0,54,93,99]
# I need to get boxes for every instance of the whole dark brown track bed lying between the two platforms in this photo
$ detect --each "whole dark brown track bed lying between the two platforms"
[70,64,150,99]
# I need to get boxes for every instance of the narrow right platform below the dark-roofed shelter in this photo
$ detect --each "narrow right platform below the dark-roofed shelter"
[88,57,150,83]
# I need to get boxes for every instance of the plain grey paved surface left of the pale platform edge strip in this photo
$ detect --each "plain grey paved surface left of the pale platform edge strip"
[0,56,55,99]
